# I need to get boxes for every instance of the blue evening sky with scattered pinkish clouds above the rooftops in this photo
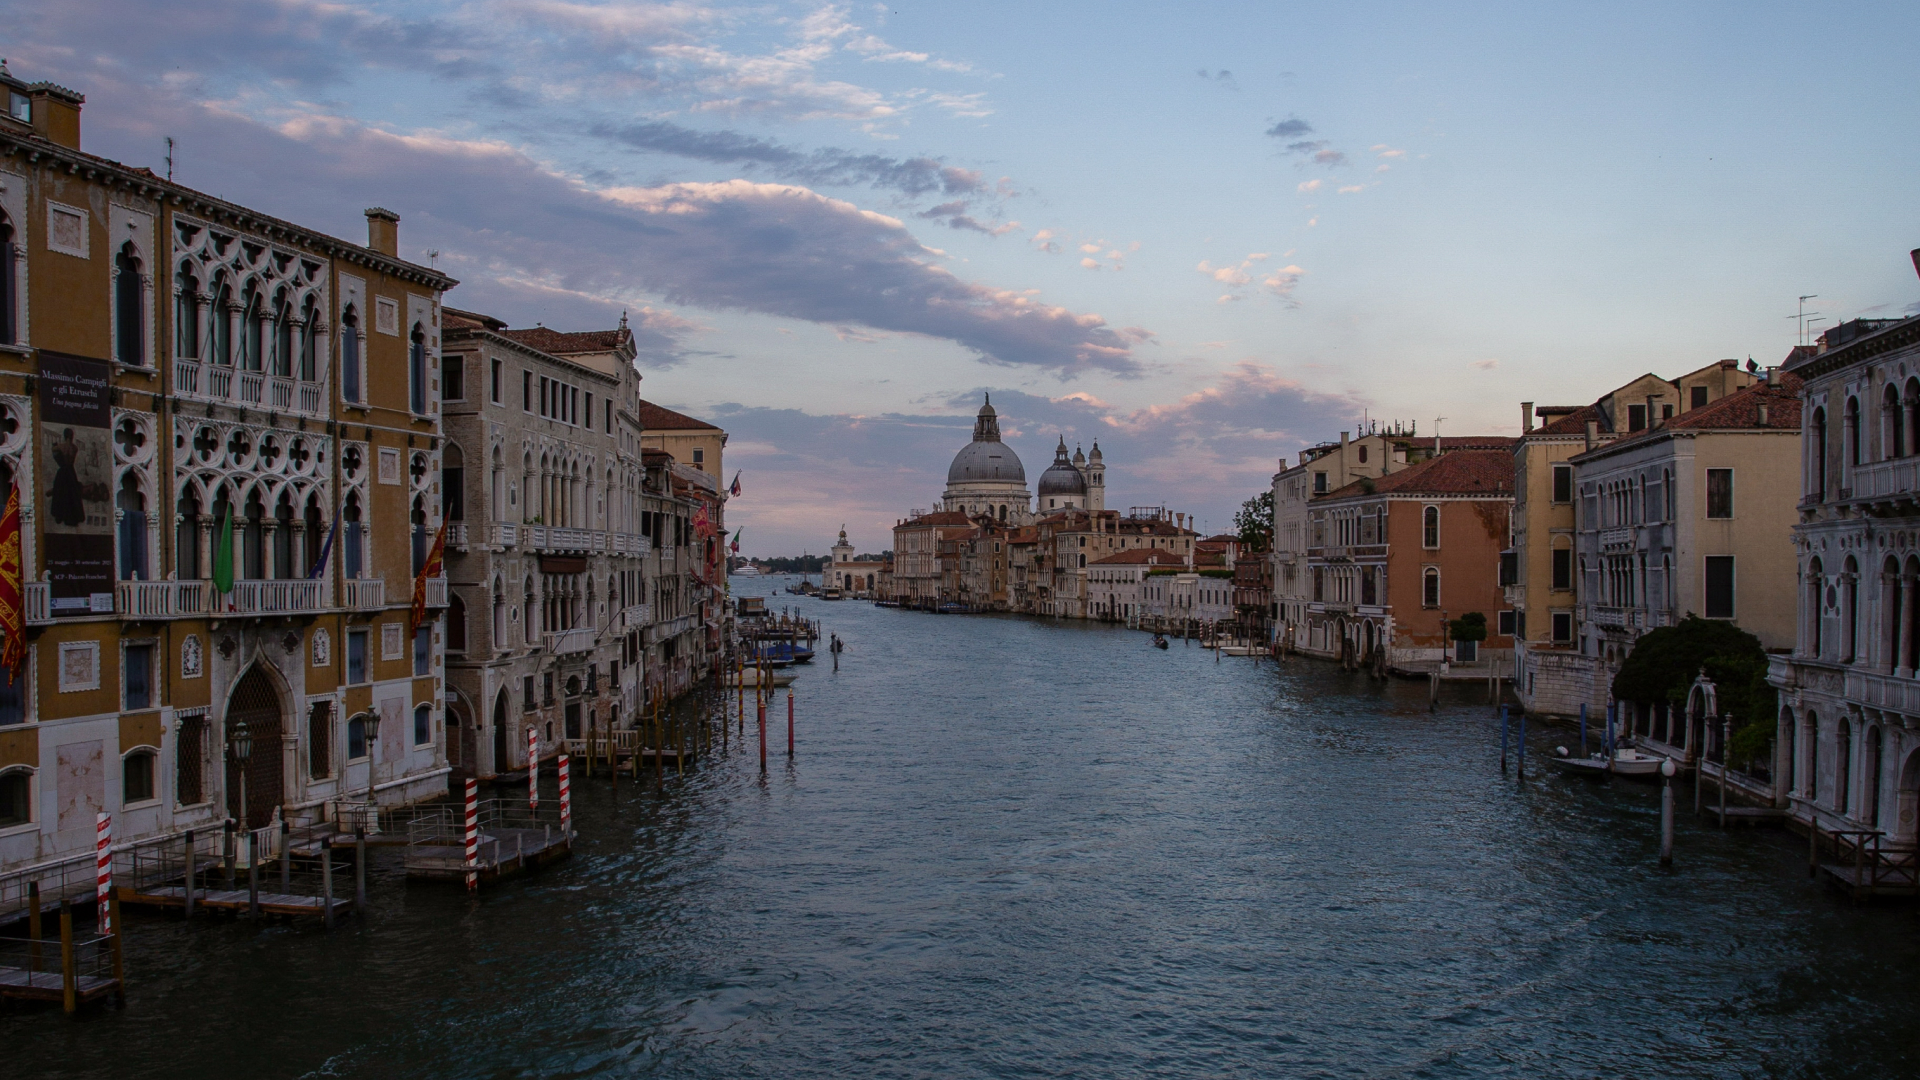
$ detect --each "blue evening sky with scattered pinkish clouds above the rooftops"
[15,0,1920,555]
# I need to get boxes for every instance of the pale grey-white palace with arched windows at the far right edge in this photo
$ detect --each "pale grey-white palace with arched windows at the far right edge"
[1774,311,1920,847]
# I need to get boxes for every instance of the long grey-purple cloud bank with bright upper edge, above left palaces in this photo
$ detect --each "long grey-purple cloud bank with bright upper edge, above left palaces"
[78,81,1139,375]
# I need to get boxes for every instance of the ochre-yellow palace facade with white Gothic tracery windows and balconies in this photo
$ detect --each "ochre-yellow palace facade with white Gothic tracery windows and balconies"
[0,65,455,883]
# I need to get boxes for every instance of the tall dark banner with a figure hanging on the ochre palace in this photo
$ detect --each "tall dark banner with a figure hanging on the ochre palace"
[36,350,113,615]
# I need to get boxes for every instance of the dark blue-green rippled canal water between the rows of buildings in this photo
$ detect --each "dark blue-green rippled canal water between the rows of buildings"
[11,578,1920,1080]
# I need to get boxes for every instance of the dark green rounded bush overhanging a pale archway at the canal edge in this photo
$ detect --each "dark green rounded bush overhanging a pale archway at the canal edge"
[1613,615,1780,765]
